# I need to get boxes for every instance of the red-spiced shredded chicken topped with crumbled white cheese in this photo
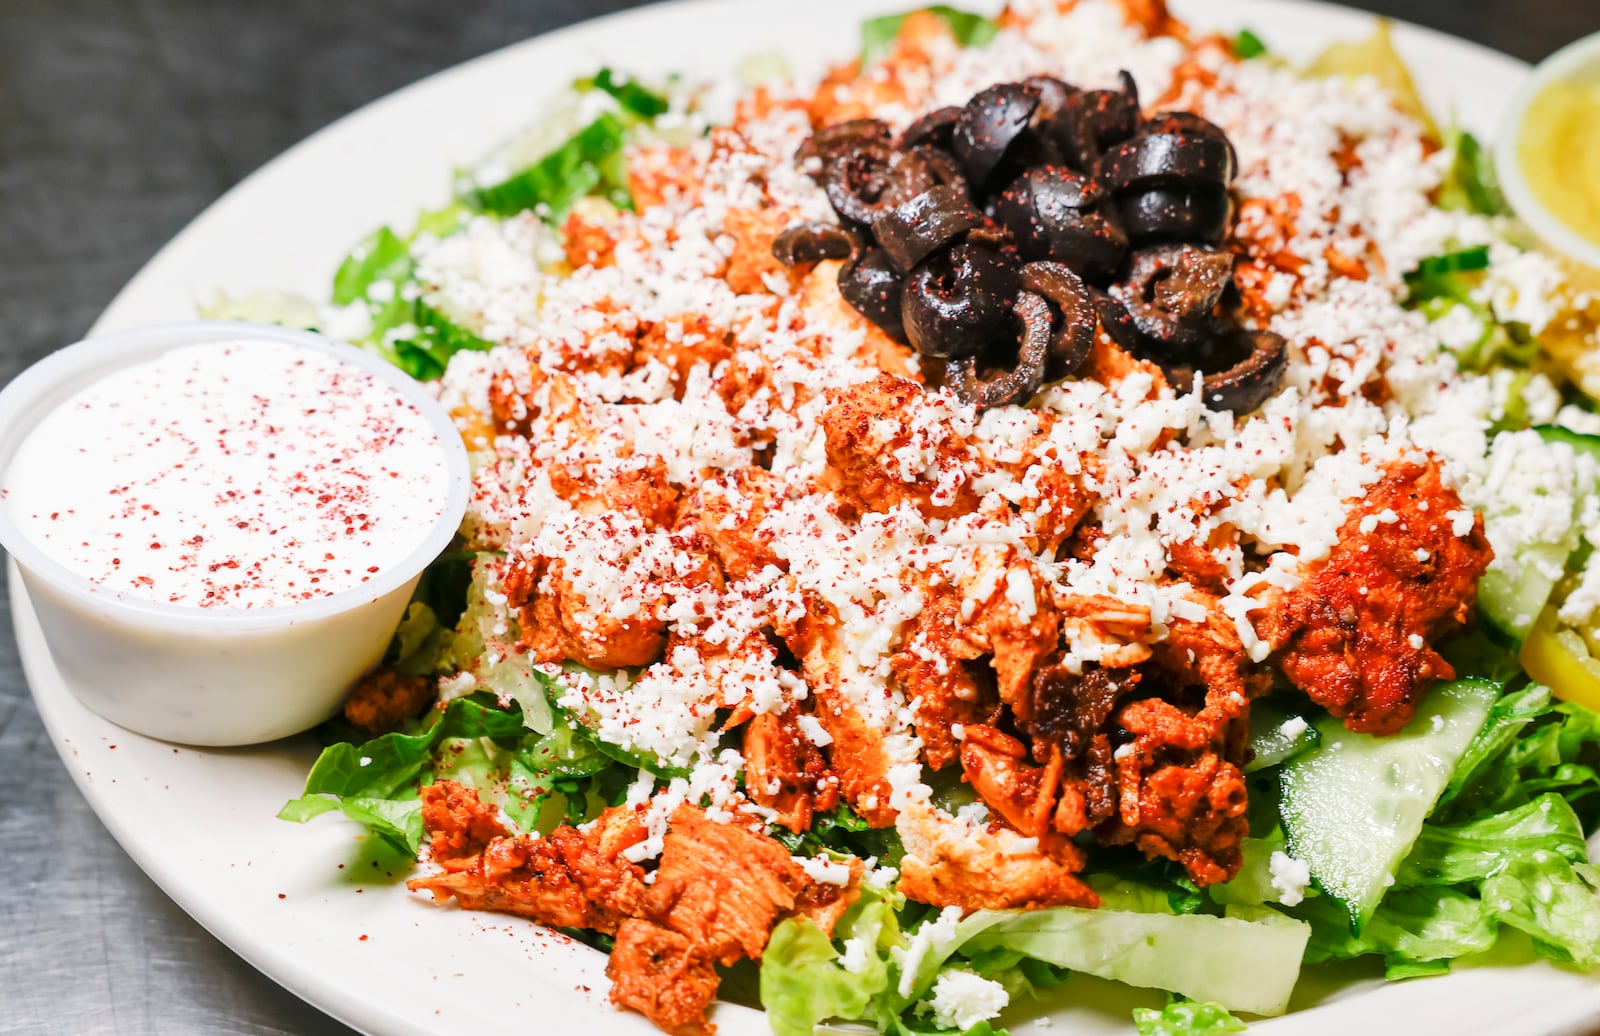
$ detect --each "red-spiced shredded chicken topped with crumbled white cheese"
[396,0,1491,1033]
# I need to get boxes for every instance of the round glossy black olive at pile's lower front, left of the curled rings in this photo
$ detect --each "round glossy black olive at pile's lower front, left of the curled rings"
[901,245,1018,360]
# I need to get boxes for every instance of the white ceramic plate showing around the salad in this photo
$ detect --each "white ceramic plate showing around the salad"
[11,0,1600,1036]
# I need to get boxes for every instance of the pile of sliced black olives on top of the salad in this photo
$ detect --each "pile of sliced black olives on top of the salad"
[773,72,1285,414]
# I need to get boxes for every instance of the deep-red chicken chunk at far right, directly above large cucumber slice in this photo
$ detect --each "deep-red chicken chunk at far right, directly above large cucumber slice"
[1254,460,1494,734]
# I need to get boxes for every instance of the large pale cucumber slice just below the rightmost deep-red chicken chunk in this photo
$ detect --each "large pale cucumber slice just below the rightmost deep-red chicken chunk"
[1278,679,1499,934]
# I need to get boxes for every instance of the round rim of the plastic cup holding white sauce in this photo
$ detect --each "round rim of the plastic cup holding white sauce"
[0,320,470,633]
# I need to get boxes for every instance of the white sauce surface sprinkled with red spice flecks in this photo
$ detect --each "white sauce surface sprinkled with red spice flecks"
[0,335,450,608]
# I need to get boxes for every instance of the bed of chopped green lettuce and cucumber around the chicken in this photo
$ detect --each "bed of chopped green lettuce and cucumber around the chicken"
[265,6,1600,1036]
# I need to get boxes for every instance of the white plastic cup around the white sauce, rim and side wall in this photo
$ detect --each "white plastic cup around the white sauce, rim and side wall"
[0,321,470,745]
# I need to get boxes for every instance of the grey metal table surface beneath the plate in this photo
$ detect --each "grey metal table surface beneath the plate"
[0,0,1600,1036]
